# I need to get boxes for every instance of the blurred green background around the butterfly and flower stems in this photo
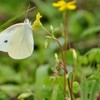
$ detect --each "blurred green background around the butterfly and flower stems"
[0,0,100,100]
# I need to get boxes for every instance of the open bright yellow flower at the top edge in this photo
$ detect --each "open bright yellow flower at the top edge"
[53,0,76,11]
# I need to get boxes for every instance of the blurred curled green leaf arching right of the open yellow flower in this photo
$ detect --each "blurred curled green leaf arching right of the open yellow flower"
[69,10,94,39]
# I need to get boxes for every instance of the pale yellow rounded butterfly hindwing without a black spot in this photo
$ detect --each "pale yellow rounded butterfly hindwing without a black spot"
[8,24,34,59]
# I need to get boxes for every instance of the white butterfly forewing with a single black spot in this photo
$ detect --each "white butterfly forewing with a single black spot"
[0,23,23,52]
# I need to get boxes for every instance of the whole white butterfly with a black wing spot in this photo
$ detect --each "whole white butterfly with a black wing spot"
[0,19,34,59]
